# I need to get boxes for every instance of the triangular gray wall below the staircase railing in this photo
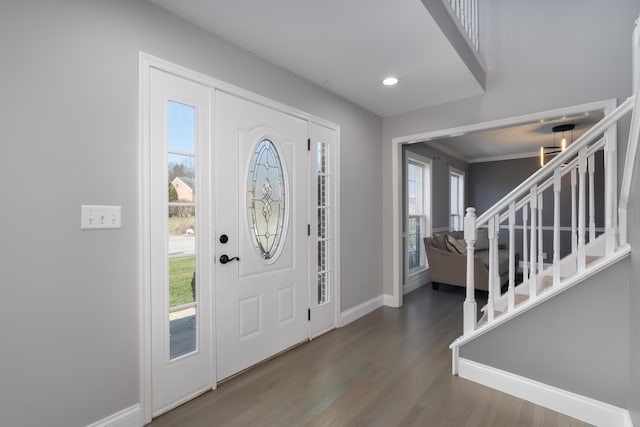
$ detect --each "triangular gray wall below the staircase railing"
[460,258,637,408]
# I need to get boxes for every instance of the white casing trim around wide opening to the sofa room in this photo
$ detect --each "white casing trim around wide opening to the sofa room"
[391,99,617,307]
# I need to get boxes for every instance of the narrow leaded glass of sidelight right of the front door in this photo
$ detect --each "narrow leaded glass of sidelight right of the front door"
[316,142,331,305]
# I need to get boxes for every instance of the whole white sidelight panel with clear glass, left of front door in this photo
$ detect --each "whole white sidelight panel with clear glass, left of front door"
[149,68,213,415]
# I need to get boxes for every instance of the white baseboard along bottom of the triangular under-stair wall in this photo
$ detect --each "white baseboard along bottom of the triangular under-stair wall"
[458,358,633,427]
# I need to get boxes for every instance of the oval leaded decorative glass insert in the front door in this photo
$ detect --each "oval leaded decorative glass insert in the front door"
[247,139,287,259]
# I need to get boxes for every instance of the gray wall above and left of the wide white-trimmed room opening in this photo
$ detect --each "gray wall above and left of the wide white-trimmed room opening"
[382,0,640,294]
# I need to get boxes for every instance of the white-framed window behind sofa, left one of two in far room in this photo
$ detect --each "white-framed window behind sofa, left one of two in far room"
[405,155,431,274]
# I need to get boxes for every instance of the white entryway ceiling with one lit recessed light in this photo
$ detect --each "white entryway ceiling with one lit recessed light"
[150,0,482,117]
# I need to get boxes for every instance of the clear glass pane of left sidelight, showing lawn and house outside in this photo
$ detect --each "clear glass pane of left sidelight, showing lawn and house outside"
[167,101,198,359]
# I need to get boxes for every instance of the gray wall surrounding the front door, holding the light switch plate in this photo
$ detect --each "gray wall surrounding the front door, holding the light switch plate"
[0,0,382,426]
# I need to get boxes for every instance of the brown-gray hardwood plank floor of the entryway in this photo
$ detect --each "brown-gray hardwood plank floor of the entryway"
[150,285,587,427]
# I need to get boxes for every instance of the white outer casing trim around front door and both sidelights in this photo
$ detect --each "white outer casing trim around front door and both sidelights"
[137,52,340,424]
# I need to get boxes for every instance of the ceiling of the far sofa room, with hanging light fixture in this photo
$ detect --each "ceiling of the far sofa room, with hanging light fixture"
[426,110,604,162]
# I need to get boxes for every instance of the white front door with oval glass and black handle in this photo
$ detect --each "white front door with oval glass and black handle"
[214,91,309,380]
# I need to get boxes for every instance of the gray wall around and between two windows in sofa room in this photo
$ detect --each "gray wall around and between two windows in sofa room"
[403,143,468,230]
